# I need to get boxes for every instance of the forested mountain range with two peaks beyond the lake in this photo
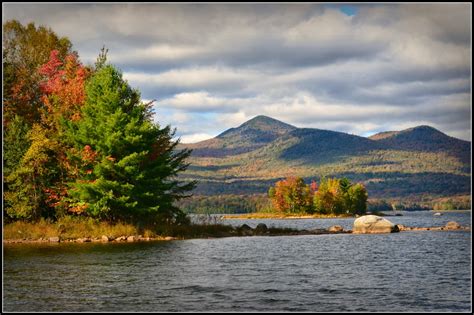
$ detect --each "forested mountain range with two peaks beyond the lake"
[180,116,471,202]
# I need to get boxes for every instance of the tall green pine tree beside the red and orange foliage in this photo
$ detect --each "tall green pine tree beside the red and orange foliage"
[63,65,195,222]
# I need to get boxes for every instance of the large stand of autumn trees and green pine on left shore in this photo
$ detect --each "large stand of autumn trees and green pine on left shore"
[3,20,195,222]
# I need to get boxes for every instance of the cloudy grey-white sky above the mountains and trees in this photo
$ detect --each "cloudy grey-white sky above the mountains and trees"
[3,3,472,143]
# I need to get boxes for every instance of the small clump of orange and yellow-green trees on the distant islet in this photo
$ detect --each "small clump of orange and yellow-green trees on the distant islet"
[268,177,368,214]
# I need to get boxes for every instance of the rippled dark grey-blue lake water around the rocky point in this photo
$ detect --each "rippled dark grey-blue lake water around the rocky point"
[3,211,472,312]
